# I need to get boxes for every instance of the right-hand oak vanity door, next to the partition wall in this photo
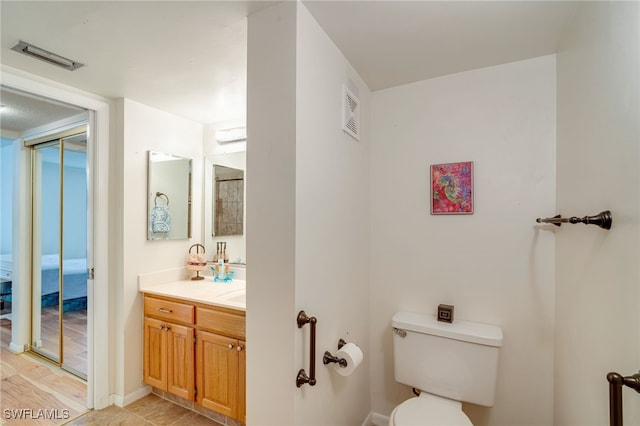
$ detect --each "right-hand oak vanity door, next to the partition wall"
[196,331,239,418]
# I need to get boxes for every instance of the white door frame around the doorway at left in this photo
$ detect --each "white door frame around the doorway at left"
[0,67,113,409]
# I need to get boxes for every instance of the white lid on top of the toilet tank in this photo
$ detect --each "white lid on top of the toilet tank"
[391,312,502,347]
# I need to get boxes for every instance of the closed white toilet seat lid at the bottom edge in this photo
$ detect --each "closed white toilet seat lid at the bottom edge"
[393,398,473,426]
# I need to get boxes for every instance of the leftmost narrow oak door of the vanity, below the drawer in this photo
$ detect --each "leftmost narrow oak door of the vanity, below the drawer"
[144,317,167,390]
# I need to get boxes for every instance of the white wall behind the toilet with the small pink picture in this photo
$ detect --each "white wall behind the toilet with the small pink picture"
[370,56,556,426]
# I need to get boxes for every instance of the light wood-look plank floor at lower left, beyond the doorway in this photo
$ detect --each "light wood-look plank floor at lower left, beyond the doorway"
[0,318,87,425]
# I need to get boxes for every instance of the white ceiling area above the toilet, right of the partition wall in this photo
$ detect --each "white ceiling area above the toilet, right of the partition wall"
[304,0,579,90]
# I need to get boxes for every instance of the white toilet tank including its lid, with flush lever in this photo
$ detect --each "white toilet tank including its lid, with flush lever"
[391,312,502,407]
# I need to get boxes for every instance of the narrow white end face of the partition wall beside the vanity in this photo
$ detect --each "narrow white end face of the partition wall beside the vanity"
[246,2,301,425]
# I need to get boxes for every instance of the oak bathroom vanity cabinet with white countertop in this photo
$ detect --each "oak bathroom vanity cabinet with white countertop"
[140,280,246,423]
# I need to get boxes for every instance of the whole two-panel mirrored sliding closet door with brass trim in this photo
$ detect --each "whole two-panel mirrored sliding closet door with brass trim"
[31,127,88,378]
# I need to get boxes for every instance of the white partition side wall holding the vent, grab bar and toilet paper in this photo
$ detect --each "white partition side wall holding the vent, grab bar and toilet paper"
[292,5,371,425]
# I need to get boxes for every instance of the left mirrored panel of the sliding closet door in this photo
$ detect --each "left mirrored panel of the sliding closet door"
[31,143,61,362]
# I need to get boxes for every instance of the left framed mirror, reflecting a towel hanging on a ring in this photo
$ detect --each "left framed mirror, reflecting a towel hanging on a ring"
[147,151,191,241]
